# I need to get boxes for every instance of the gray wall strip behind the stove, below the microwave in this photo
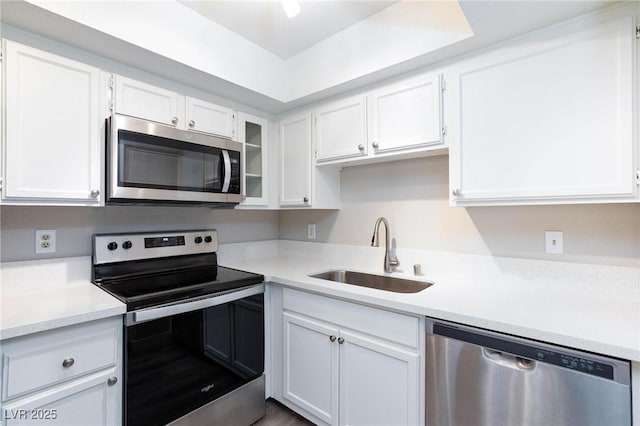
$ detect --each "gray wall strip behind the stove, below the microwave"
[0,206,278,262]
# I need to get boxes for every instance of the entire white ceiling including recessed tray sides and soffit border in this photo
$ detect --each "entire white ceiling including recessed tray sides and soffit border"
[0,0,620,114]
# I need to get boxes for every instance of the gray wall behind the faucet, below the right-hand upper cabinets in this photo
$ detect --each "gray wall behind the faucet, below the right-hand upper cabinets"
[280,156,640,267]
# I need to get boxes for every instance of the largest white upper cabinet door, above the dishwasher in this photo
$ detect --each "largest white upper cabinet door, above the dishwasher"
[450,17,637,205]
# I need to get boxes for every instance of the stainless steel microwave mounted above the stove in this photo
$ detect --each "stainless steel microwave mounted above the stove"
[106,114,242,206]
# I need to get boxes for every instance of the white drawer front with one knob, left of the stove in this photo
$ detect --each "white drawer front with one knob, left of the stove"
[2,318,122,401]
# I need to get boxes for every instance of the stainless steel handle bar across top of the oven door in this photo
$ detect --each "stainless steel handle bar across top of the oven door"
[127,284,264,326]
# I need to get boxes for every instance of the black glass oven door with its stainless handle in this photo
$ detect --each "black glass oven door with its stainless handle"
[125,284,265,426]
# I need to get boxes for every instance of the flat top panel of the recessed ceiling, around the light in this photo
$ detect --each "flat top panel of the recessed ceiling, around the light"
[179,0,397,59]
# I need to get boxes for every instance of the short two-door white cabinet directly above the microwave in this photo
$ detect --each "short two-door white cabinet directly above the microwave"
[114,75,235,138]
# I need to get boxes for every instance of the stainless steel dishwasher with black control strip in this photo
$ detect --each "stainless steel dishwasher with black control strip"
[426,318,631,426]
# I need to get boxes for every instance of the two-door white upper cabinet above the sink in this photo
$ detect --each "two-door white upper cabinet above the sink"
[314,72,444,164]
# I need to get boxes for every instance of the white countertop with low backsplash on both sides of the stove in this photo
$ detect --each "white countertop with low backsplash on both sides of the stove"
[0,240,640,361]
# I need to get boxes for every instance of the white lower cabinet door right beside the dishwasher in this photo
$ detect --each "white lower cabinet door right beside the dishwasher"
[339,330,421,426]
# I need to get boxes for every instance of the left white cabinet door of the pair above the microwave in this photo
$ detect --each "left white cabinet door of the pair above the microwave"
[114,75,185,129]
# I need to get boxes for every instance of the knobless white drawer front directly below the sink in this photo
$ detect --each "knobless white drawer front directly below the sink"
[282,288,421,349]
